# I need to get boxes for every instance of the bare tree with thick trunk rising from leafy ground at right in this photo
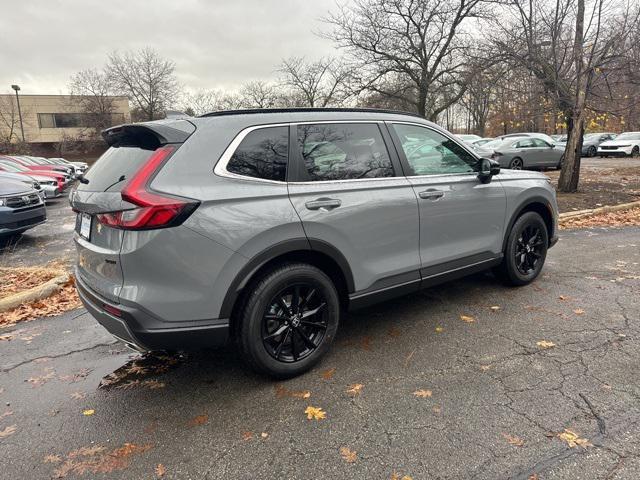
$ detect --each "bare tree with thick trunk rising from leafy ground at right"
[494,0,639,192]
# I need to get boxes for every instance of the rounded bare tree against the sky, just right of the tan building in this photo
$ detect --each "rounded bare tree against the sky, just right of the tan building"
[106,48,179,120]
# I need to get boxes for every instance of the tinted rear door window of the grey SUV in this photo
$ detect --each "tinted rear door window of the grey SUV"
[297,123,394,182]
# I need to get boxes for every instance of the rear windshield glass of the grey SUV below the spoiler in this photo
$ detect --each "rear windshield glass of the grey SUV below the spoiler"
[78,147,153,192]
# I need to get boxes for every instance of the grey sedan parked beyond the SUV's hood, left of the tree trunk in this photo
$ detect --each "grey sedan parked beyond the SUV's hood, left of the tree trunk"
[491,137,564,170]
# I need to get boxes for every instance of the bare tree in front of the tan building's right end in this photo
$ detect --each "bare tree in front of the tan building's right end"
[69,69,115,137]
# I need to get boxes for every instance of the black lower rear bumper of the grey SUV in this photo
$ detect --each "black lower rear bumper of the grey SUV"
[76,272,229,351]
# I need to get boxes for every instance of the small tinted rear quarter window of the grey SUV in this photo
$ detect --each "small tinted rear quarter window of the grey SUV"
[227,127,289,181]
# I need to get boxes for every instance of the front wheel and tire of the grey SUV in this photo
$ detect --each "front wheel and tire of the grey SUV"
[493,212,549,287]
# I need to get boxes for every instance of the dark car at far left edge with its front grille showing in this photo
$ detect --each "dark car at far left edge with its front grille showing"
[0,179,47,236]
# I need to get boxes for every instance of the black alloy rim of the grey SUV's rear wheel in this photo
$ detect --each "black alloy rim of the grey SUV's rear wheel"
[262,283,327,363]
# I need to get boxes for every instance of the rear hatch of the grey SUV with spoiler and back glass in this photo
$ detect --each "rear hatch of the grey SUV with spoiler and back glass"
[70,121,195,302]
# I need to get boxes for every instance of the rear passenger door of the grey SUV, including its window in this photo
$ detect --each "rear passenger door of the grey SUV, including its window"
[289,122,420,295]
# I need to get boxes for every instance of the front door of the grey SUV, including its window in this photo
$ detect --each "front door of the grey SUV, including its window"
[389,123,506,278]
